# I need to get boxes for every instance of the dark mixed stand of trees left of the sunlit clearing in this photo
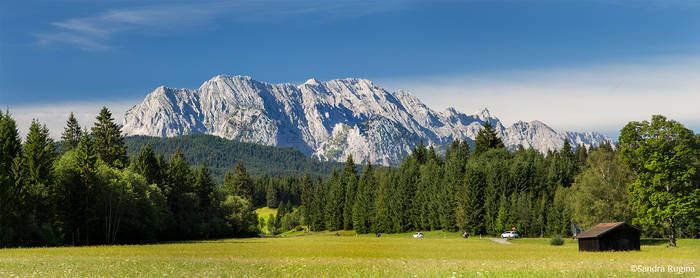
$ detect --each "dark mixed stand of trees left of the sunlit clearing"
[0,108,257,247]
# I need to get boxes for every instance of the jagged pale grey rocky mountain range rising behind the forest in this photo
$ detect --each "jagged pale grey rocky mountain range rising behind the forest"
[122,75,609,165]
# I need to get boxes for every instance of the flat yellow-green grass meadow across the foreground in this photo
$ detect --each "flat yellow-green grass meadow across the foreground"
[0,232,700,277]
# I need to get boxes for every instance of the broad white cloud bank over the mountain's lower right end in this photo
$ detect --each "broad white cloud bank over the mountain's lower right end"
[378,57,700,135]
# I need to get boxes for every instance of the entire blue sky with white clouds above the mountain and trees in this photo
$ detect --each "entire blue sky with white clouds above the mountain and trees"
[0,0,700,139]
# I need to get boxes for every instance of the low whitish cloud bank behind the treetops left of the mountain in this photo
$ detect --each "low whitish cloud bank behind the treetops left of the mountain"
[3,100,138,141]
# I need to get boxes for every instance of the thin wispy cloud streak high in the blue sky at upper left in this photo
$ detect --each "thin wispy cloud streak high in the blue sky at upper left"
[37,0,412,51]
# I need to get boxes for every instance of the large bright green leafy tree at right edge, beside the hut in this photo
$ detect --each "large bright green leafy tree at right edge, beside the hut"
[619,115,700,246]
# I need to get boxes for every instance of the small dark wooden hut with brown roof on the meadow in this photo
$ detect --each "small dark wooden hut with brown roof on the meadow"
[576,222,642,251]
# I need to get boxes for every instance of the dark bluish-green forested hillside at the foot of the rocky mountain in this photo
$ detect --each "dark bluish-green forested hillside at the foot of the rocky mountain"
[124,134,342,184]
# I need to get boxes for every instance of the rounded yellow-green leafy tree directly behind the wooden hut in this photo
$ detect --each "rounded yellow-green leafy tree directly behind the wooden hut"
[567,149,634,228]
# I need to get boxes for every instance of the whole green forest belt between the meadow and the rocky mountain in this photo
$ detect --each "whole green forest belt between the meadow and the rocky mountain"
[0,108,700,247]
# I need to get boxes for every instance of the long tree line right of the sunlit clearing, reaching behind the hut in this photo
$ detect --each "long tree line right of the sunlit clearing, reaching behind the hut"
[288,119,700,246]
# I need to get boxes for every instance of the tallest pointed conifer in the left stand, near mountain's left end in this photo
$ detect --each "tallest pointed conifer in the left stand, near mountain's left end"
[92,107,127,168]
